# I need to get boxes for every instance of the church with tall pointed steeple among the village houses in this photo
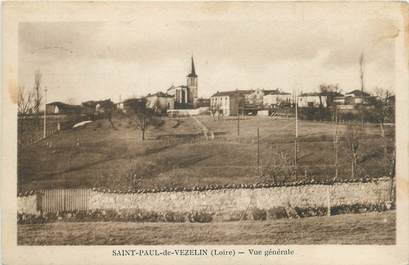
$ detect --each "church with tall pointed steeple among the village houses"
[167,56,198,109]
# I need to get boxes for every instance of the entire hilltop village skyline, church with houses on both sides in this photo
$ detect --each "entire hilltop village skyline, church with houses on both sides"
[46,56,392,116]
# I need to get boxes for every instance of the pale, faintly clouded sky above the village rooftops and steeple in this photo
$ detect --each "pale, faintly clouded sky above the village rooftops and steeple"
[18,3,397,104]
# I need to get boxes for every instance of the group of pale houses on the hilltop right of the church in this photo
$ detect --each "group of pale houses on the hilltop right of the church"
[210,87,394,116]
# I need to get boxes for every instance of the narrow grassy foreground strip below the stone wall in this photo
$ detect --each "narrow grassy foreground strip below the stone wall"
[18,211,396,245]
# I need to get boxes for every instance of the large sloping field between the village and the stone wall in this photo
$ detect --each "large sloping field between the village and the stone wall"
[18,112,394,191]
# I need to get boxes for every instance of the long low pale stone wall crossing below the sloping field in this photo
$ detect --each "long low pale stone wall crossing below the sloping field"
[18,178,391,214]
